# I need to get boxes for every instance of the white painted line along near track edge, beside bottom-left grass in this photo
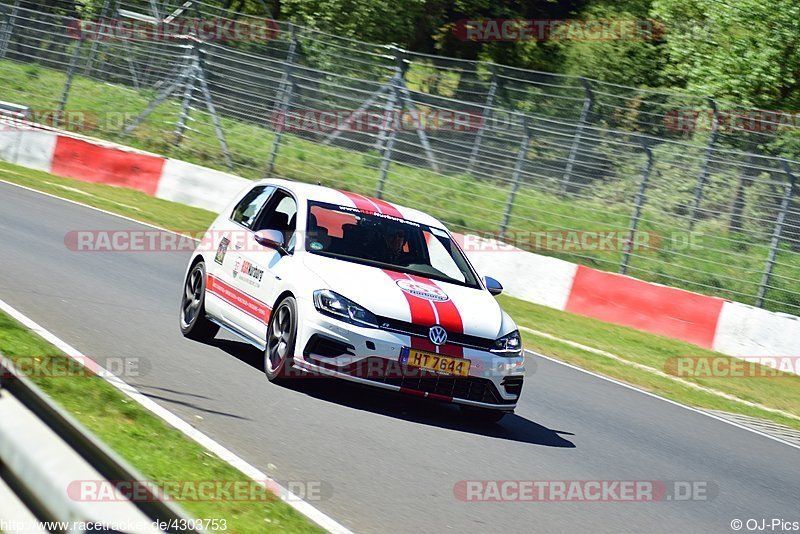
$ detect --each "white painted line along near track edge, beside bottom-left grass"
[0,300,351,534]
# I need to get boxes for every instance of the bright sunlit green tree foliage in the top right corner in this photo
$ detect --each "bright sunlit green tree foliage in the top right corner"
[653,0,800,109]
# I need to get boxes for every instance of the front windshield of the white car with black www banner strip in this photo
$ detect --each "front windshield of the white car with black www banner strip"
[306,202,480,288]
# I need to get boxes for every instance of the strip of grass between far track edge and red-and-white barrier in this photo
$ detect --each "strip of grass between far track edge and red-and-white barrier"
[0,162,800,429]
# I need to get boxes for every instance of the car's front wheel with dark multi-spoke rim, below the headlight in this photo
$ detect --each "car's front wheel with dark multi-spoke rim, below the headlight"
[264,297,297,382]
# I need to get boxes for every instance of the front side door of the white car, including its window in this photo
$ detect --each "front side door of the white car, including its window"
[223,188,297,341]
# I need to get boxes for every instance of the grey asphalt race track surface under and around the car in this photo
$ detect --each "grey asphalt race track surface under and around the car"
[0,183,800,532]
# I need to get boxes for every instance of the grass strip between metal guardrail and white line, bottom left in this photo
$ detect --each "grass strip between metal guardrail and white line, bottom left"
[0,313,321,533]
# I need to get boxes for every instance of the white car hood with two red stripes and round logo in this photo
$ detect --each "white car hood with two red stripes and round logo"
[303,253,503,339]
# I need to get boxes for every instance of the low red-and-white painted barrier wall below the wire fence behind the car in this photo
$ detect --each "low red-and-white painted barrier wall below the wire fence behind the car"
[0,128,800,357]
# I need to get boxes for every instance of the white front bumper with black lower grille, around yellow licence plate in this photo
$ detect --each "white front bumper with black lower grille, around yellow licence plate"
[294,301,525,412]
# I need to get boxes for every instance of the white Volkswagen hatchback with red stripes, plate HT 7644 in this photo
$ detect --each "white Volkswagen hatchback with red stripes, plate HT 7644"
[180,180,525,421]
